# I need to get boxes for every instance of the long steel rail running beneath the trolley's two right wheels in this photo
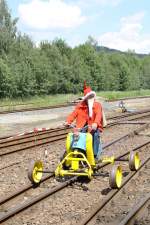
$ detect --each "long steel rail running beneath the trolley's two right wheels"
[76,157,150,225]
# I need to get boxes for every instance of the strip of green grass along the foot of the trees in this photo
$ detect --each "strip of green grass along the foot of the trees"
[0,90,150,111]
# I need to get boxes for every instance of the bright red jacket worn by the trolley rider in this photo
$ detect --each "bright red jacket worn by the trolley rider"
[67,101,103,131]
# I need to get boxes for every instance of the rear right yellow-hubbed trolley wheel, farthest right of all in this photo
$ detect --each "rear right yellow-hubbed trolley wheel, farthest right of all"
[129,151,140,171]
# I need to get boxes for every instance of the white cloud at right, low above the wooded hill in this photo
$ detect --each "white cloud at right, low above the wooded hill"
[98,12,150,53]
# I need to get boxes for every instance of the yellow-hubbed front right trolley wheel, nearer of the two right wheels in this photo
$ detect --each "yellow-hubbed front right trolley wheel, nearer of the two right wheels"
[109,165,122,188]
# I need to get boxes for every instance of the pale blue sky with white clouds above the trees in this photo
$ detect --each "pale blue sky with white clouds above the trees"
[6,0,150,53]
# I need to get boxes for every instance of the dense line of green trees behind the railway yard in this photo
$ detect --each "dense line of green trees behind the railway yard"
[0,0,150,98]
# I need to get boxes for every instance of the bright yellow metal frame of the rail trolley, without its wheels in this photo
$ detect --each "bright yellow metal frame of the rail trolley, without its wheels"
[55,133,116,179]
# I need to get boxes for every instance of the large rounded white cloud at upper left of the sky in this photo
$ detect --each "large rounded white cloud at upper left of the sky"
[18,0,86,30]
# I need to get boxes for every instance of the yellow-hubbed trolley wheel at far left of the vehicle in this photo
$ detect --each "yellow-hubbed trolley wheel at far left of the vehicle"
[28,160,43,184]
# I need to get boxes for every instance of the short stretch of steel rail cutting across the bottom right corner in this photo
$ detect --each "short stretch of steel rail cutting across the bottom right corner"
[118,193,150,225]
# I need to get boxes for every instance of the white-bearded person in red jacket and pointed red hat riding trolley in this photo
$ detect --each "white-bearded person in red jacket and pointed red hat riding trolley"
[64,83,103,160]
